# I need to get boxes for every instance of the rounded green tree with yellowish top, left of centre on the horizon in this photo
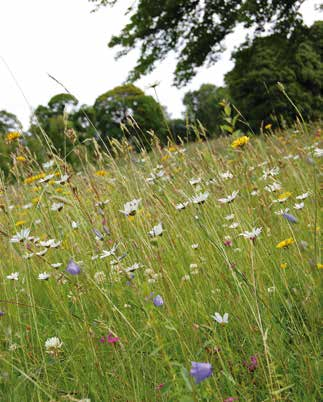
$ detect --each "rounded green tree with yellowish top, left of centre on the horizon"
[94,84,166,148]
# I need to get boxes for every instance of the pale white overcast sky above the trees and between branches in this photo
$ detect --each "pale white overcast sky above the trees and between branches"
[0,0,322,128]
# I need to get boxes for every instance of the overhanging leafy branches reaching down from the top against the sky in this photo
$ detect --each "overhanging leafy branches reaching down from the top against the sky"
[89,0,304,86]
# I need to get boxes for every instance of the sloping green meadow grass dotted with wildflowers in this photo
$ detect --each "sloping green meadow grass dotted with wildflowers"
[0,127,322,402]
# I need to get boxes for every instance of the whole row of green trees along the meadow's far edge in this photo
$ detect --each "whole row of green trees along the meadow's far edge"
[0,21,323,177]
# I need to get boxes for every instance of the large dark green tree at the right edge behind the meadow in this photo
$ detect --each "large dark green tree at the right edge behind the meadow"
[225,21,323,129]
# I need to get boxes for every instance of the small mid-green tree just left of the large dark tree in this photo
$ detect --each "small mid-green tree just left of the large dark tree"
[183,84,229,136]
